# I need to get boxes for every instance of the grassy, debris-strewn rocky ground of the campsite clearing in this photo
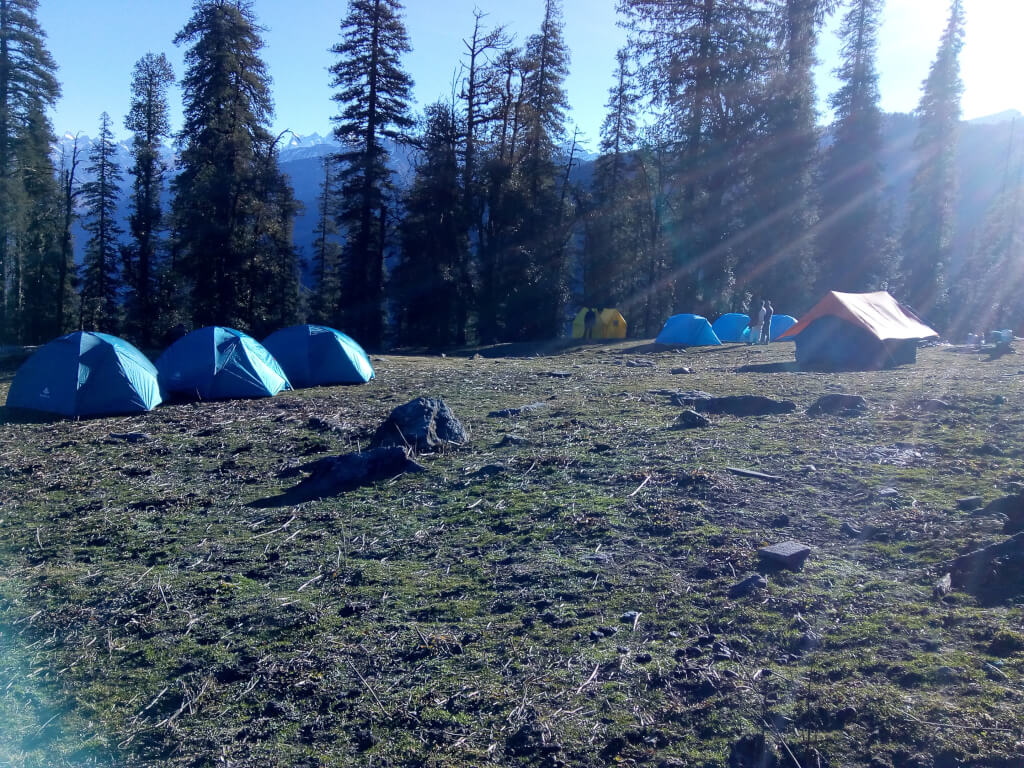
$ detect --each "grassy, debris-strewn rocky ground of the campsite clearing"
[0,341,1024,768]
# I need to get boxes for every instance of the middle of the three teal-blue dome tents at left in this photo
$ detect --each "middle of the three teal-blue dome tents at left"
[157,326,291,400]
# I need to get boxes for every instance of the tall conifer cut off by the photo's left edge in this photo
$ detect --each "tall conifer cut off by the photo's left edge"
[0,0,62,342]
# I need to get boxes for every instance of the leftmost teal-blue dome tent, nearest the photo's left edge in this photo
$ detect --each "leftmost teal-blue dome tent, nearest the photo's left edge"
[7,331,161,416]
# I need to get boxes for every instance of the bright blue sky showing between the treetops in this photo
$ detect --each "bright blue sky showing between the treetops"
[39,0,1024,148]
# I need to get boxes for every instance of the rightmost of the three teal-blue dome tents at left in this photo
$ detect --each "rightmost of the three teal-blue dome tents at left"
[263,326,374,387]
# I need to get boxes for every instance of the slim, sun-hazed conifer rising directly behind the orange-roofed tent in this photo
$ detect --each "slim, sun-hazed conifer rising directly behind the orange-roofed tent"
[900,0,965,326]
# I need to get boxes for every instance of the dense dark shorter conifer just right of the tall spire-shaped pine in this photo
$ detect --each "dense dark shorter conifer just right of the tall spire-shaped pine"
[395,102,469,347]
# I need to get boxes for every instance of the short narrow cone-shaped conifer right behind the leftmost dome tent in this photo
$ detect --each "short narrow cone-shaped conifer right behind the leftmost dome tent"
[79,112,123,334]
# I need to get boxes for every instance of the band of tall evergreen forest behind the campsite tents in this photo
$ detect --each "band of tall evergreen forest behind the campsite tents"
[0,0,1024,349]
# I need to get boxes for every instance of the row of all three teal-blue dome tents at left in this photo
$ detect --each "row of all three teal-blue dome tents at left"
[7,326,374,417]
